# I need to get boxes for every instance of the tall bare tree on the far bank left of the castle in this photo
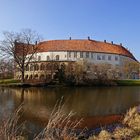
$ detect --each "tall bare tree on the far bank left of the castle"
[0,29,41,83]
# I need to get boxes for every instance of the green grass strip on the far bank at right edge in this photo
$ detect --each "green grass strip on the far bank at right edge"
[116,80,140,86]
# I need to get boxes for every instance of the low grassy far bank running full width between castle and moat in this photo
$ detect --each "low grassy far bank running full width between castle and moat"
[0,79,140,87]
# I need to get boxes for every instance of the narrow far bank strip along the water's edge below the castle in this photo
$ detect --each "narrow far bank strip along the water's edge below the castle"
[0,79,140,87]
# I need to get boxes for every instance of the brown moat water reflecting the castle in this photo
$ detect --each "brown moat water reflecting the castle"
[0,86,140,138]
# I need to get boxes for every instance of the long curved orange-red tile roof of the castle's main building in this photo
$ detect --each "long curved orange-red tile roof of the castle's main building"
[38,40,136,60]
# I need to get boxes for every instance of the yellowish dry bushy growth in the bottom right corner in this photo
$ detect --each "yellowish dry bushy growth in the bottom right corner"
[89,106,140,140]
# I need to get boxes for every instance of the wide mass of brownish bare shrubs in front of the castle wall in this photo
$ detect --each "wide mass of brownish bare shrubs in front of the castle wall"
[65,60,120,84]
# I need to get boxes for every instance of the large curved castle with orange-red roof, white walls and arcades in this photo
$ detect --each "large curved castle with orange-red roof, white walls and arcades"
[15,37,139,79]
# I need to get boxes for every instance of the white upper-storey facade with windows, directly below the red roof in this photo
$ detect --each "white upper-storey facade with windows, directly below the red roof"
[28,51,130,65]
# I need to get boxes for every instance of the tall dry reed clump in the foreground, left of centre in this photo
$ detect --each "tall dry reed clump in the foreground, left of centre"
[34,97,84,140]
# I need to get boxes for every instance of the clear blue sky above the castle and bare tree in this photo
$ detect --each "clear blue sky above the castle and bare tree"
[0,0,140,60]
